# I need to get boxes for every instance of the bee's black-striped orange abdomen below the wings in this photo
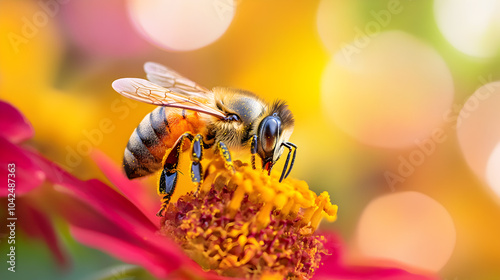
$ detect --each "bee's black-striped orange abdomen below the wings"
[123,107,203,179]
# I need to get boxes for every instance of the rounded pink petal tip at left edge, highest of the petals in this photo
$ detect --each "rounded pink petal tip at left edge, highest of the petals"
[0,101,34,143]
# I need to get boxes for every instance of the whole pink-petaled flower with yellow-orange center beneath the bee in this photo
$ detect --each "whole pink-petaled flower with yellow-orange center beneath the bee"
[0,99,442,280]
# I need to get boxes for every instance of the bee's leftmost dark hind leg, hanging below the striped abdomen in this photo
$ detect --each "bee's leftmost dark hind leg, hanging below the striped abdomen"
[156,133,193,217]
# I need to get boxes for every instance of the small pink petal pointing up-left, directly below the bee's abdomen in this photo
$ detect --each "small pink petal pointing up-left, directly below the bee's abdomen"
[92,151,160,224]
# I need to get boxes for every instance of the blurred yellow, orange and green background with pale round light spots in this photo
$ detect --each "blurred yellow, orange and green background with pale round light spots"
[0,0,500,280]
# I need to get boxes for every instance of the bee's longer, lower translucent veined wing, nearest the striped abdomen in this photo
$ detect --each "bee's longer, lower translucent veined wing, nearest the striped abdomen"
[112,78,226,118]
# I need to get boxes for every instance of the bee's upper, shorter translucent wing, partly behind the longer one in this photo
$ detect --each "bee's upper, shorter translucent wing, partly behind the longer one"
[144,62,213,96]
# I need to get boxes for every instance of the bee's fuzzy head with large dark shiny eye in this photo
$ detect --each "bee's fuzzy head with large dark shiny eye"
[257,101,294,171]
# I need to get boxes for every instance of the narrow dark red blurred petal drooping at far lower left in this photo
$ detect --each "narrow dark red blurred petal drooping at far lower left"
[17,198,68,267]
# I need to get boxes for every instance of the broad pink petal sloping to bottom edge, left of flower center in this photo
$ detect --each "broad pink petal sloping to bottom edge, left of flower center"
[56,195,204,277]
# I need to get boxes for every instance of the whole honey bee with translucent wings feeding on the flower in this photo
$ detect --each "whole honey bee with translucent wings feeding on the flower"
[112,62,297,216]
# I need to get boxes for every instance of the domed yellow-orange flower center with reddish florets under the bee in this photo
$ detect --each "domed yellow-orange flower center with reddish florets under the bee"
[161,160,337,279]
